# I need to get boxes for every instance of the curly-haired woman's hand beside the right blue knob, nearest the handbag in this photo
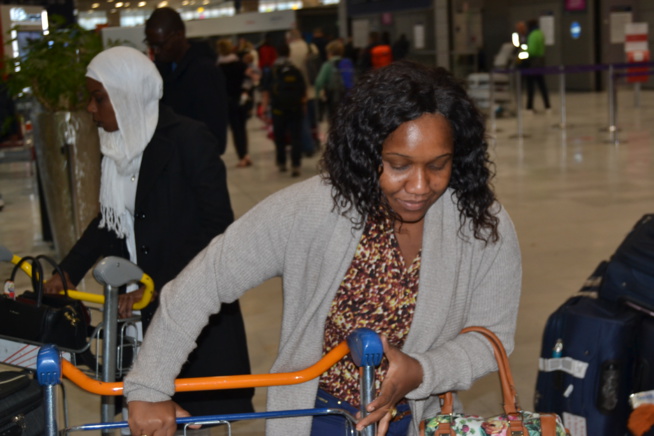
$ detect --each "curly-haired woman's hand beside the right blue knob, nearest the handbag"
[357,335,423,436]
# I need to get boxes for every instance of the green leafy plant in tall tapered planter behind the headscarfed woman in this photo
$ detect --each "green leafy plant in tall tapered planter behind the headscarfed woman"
[5,17,102,258]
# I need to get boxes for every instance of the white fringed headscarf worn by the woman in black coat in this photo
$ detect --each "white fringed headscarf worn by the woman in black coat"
[86,47,163,261]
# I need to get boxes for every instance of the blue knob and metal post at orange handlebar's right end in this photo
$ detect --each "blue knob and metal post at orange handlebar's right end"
[347,328,384,436]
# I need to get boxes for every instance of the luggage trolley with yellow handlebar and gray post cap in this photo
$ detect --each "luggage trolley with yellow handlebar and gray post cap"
[0,246,154,430]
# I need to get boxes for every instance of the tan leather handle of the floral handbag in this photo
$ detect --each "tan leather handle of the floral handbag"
[441,327,520,415]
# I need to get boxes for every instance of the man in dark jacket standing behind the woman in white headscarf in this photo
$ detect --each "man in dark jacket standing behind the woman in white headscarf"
[145,8,228,154]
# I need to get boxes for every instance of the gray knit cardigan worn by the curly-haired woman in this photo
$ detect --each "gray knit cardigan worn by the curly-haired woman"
[125,176,522,436]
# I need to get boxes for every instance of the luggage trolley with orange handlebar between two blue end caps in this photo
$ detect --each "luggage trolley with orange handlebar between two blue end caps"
[37,328,383,436]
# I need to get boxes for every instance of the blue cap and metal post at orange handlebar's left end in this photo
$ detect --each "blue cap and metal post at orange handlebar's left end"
[36,345,61,436]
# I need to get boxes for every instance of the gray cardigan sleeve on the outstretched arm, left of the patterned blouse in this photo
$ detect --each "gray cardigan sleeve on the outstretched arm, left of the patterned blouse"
[124,179,318,401]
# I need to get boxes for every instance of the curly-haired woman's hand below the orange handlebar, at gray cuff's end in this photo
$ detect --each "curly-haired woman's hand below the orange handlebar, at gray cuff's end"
[127,400,200,436]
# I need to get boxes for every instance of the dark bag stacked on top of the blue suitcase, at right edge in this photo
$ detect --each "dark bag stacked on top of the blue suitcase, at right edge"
[599,214,654,310]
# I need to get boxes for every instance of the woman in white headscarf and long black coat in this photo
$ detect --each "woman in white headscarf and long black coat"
[46,47,253,415]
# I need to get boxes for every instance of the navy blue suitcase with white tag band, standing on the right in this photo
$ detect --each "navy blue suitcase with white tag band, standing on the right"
[534,295,640,436]
